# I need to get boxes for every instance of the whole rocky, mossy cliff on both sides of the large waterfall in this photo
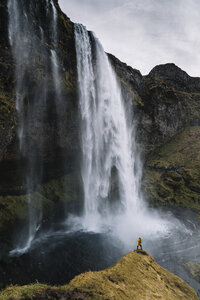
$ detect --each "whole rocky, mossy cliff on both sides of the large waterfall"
[0,0,200,248]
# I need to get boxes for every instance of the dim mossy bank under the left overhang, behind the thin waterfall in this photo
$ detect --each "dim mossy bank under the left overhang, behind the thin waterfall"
[0,173,81,242]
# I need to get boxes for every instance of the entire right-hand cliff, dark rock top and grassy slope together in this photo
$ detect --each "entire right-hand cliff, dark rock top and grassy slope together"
[110,55,200,211]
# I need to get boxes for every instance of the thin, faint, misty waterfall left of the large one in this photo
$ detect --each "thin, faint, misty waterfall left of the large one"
[8,0,58,253]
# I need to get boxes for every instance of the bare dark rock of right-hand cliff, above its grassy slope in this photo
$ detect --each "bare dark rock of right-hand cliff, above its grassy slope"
[110,56,200,153]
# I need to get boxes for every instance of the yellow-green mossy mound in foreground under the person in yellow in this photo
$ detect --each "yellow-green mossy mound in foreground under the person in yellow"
[0,251,198,300]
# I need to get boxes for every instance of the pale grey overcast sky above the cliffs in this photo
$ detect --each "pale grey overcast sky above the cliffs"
[59,0,200,77]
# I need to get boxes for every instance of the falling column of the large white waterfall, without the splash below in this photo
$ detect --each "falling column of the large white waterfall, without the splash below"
[75,25,140,226]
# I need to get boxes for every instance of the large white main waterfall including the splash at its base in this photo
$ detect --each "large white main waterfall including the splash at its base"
[71,24,171,244]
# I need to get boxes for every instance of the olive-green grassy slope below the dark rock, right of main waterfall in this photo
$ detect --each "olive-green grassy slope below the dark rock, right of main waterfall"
[144,126,200,210]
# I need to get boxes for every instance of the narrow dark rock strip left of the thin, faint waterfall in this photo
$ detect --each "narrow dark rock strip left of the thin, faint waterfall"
[0,0,16,161]
